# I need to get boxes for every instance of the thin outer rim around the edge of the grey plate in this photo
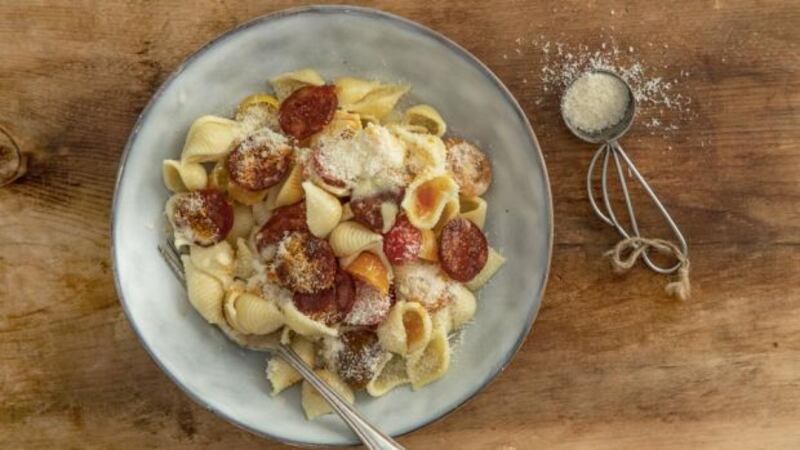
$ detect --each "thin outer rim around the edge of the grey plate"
[109,5,554,448]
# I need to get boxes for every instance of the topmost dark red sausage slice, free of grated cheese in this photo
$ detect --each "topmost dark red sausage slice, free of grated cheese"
[278,86,338,141]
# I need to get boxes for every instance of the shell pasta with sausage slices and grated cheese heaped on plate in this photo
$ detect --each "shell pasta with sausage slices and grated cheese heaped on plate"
[162,69,504,419]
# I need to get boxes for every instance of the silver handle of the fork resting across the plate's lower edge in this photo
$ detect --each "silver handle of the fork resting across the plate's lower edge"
[278,344,404,450]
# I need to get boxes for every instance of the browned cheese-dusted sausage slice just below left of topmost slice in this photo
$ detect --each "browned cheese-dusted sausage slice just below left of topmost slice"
[227,129,293,191]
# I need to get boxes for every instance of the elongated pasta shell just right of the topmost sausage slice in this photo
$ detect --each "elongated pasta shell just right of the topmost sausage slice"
[335,77,409,120]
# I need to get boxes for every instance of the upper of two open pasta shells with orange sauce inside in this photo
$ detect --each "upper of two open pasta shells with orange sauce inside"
[401,175,458,230]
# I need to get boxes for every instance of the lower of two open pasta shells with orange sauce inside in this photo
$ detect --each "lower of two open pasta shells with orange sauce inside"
[378,301,432,355]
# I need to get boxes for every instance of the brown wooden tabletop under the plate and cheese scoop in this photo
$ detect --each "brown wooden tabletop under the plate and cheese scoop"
[0,0,800,449]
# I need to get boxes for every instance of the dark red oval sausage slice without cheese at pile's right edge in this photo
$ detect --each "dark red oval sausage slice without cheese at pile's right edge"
[439,217,489,283]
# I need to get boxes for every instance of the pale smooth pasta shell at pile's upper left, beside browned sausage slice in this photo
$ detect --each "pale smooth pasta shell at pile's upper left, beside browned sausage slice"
[181,116,239,163]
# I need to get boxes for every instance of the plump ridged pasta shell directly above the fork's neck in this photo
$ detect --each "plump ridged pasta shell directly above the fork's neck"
[225,291,283,335]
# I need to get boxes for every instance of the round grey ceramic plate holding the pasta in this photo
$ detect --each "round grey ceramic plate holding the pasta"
[111,7,553,445]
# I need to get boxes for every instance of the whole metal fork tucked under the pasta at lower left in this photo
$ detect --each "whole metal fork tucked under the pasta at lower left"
[158,237,404,450]
